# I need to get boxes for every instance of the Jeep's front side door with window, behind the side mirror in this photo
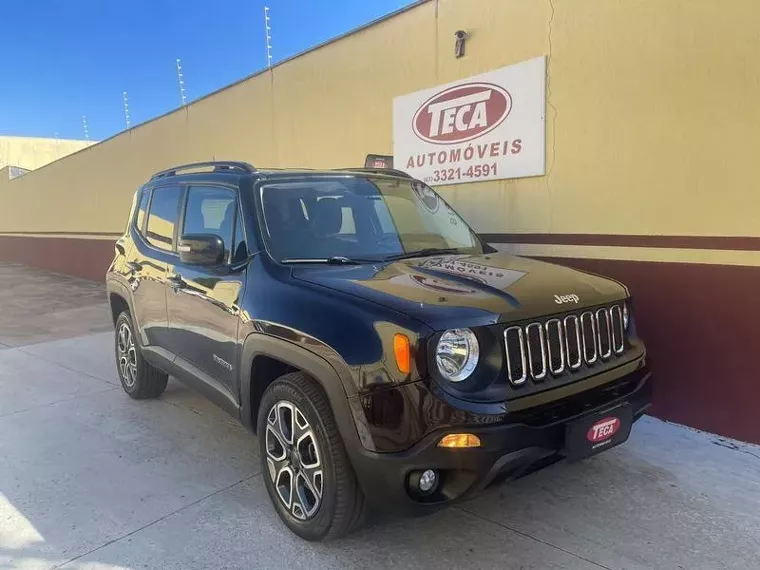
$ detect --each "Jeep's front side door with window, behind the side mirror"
[167,184,248,405]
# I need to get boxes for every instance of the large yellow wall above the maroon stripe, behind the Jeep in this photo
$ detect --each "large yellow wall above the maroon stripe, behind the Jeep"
[0,0,760,253]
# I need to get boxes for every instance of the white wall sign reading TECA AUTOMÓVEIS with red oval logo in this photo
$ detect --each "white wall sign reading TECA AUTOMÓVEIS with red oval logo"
[393,56,546,185]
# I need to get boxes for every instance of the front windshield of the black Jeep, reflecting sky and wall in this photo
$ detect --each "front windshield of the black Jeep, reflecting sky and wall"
[259,176,483,262]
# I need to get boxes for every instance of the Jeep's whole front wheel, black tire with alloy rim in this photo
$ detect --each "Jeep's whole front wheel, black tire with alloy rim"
[257,372,366,541]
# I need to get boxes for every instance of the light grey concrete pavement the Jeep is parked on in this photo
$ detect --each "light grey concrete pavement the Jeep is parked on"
[0,264,760,570]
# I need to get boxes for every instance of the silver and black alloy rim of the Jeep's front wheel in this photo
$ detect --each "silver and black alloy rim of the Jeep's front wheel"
[264,400,324,521]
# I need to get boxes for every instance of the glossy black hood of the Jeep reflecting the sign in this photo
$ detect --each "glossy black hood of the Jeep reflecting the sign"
[293,253,628,330]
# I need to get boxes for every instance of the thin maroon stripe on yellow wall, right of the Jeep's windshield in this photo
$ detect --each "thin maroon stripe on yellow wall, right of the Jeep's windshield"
[480,233,760,251]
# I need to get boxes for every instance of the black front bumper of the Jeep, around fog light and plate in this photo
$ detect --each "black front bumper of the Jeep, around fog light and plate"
[352,366,652,513]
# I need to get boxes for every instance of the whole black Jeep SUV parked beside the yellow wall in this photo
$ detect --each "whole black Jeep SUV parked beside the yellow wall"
[106,162,651,540]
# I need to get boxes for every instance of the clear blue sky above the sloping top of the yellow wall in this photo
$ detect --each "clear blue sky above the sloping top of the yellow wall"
[0,0,412,140]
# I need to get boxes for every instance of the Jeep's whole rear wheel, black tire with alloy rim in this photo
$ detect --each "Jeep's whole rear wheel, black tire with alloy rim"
[114,311,169,400]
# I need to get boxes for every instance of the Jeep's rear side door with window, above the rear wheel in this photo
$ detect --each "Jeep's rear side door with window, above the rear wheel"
[126,185,181,348]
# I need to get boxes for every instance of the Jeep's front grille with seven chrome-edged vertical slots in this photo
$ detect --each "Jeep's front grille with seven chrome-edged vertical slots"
[504,305,625,386]
